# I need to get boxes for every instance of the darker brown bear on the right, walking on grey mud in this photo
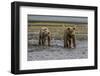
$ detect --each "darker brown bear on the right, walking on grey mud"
[64,27,76,48]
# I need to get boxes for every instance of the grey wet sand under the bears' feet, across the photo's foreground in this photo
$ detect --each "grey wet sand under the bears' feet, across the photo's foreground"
[27,40,88,61]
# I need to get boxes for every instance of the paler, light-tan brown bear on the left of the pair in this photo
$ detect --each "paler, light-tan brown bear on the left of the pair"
[39,27,51,46]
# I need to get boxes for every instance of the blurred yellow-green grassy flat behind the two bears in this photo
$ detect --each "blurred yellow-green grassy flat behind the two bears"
[28,22,88,40]
